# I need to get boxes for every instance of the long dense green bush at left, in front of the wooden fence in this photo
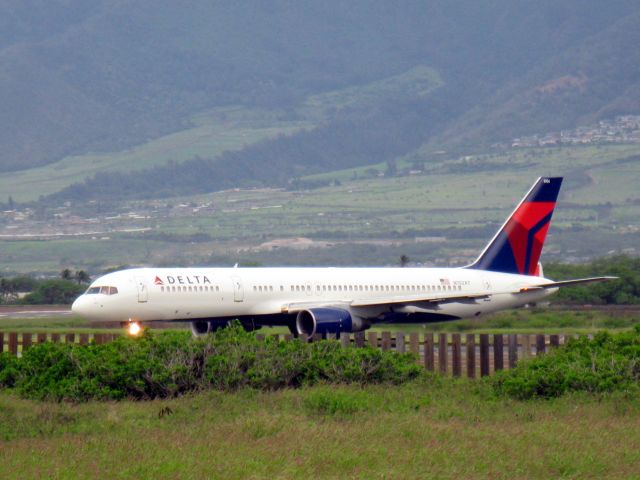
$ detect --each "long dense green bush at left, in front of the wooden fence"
[0,325,421,401]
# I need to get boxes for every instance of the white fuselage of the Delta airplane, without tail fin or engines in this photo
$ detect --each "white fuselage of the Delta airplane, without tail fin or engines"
[73,268,555,324]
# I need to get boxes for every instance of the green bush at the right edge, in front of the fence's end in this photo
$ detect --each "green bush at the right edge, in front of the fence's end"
[489,326,640,400]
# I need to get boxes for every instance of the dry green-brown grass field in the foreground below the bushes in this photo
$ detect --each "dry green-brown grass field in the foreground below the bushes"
[0,377,640,479]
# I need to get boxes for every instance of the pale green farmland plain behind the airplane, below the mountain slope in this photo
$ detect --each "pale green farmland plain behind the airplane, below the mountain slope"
[0,145,640,272]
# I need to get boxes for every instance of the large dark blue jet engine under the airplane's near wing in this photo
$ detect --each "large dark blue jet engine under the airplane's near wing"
[296,308,370,336]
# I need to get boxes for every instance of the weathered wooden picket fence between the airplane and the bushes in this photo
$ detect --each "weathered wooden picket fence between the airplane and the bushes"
[0,332,573,378]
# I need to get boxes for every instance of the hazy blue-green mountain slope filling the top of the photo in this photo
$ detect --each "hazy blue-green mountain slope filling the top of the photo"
[0,0,640,199]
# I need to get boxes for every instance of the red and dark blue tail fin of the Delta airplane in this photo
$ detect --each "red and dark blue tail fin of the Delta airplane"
[468,177,562,275]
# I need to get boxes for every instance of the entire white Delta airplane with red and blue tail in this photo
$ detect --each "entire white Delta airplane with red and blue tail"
[72,177,616,337]
